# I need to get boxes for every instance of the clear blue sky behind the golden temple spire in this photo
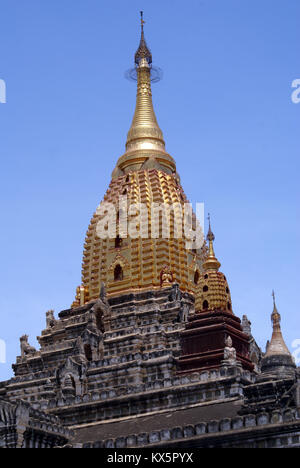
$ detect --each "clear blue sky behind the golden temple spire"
[0,0,300,379]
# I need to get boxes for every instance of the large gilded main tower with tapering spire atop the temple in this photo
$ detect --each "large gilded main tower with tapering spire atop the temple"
[73,12,206,307]
